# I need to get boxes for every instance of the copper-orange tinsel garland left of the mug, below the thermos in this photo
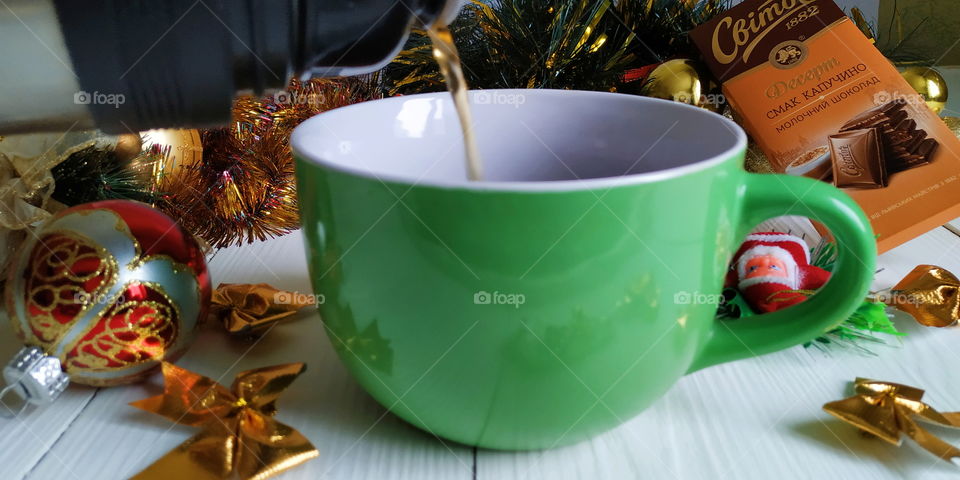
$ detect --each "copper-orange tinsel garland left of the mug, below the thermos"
[158,77,380,248]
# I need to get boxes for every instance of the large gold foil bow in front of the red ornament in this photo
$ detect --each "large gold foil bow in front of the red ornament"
[130,363,318,480]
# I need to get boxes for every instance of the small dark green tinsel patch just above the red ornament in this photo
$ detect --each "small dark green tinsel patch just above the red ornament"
[52,147,156,206]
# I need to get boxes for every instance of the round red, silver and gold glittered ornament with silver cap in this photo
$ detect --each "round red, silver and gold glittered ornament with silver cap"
[4,200,211,403]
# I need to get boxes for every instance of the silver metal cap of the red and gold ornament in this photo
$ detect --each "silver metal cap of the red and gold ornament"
[0,347,70,405]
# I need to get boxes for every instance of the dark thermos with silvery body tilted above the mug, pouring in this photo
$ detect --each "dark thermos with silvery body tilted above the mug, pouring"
[0,0,463,134]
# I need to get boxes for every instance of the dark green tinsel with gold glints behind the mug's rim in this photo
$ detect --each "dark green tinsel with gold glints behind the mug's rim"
[383,0,728,95]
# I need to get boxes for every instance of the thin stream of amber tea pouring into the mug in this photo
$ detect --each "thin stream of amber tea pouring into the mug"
[427,24,483,180]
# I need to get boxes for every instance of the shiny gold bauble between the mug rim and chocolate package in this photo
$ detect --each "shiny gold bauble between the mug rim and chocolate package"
[640,59,724,113]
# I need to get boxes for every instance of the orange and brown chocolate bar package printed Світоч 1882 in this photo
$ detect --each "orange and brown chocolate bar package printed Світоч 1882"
[690,0,960,252]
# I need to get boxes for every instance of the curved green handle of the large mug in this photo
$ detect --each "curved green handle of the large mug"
[688,173,877,373]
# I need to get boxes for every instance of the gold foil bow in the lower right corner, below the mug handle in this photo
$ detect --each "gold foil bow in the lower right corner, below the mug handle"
[823,378,960,461]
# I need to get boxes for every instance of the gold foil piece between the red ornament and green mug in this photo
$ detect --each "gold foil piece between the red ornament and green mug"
[211,283,314,334]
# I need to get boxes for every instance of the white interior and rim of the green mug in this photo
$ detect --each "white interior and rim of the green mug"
[291,90,747,189]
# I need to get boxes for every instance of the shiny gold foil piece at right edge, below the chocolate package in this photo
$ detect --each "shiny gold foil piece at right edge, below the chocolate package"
[882,265,960,327]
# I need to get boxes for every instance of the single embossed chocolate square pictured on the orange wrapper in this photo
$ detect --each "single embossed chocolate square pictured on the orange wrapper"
[830,128,887,188]
